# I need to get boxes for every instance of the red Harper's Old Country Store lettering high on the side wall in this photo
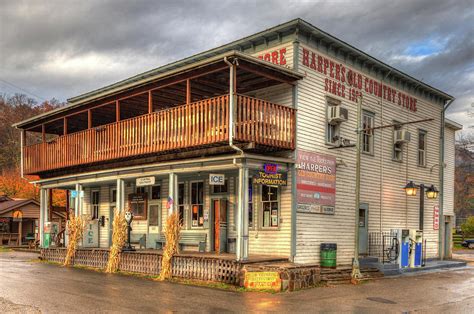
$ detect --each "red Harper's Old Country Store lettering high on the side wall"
[303,48,417,112]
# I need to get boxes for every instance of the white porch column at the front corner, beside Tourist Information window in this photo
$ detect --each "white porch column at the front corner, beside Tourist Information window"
[236,166,249,261]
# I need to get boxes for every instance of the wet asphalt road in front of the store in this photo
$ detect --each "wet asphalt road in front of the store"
[0,252,474,313]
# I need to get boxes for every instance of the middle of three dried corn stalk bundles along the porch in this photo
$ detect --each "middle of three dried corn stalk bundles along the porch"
[105,208,127,273]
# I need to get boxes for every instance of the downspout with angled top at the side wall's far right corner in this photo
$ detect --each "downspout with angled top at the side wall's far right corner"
[438,98,456,260]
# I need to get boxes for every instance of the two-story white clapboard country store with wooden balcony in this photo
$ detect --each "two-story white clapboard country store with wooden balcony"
[15,19,460,270]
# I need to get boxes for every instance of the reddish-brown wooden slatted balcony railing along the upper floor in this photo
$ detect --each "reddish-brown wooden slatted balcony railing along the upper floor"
[23,95,295,174]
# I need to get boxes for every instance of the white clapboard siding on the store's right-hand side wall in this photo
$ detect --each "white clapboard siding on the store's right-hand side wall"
[296,44,441,264]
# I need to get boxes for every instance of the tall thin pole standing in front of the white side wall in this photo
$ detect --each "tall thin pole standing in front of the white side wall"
[351,93,363,283]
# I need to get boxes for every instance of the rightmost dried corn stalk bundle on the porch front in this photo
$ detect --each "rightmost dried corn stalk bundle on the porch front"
[159,213,181,280]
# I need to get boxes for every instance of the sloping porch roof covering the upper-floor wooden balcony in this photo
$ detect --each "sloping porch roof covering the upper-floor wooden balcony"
[13,50,304,129]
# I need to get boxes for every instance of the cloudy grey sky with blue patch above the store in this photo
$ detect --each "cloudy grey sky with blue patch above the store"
[0,0,474,130]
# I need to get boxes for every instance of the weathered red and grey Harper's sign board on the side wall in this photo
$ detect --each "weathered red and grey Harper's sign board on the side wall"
[296,150,336,215]
